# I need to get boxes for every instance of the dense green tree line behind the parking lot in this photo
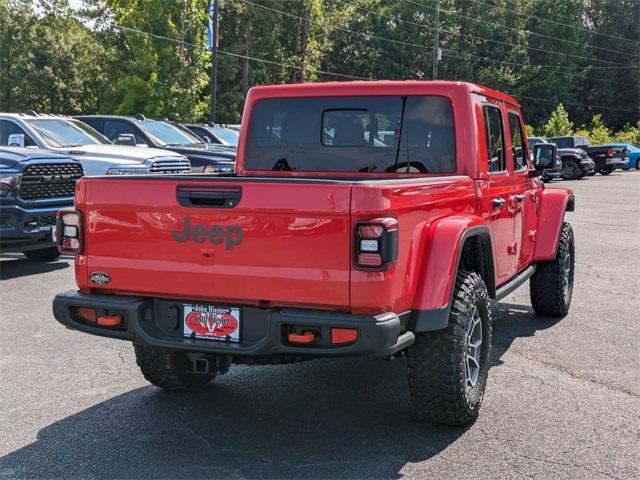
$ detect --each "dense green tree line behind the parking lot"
[0,0,640,131]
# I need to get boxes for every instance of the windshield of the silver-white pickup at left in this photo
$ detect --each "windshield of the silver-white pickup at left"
[25,118,111,148]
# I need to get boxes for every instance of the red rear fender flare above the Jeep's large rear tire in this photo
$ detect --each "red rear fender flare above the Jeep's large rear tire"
[408,215,496,332]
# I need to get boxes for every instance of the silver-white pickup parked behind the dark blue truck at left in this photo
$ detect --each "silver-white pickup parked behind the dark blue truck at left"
[0,111,191,175]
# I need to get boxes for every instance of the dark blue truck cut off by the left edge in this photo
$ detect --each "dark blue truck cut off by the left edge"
[0,147,83,261]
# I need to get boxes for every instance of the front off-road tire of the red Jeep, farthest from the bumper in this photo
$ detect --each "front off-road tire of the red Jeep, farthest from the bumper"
[529,222,575,317]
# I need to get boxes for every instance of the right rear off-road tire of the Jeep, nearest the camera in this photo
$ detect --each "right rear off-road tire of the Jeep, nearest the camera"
[408,271,492,426]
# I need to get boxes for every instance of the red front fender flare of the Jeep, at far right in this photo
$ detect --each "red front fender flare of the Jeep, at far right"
[533,188,576,262]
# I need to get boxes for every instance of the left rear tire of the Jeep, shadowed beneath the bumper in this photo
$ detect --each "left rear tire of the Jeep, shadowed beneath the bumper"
[134,344,229,392]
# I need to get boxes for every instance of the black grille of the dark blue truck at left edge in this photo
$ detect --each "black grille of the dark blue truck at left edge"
[20,163,82,200]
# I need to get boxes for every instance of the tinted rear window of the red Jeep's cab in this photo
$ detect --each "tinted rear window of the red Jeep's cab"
[245,96,456,173]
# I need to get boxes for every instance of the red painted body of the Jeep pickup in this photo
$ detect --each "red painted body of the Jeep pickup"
[71,81,570,314]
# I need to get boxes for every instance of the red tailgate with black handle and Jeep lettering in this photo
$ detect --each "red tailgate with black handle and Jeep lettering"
[78,178,351,307]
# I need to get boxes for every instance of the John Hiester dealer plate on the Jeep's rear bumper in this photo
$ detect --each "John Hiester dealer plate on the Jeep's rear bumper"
[182,303,240,342]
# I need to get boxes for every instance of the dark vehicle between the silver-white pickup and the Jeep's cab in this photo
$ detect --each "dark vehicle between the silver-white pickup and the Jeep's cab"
[75,114,236,173]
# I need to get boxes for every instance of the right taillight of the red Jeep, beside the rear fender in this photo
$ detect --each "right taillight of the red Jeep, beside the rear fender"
[354,217,398,271]
